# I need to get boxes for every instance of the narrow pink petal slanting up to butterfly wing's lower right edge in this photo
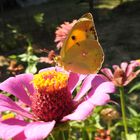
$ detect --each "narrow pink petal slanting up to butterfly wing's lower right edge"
[74,74,97,101]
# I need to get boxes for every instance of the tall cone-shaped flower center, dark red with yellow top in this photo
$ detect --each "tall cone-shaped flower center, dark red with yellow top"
[31,70,73,121]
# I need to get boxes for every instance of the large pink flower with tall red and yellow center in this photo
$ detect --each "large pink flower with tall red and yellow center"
[0,67,115,140]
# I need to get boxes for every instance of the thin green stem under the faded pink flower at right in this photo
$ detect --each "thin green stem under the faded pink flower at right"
[119,87,128,139]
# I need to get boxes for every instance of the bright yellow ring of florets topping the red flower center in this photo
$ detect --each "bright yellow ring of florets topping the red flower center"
[32,70,68,92]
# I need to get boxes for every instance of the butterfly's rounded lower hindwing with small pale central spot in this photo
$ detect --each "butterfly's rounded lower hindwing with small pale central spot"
[63,39,104,74]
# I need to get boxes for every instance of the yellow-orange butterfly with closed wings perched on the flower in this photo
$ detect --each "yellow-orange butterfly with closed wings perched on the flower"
[60,13,104,74]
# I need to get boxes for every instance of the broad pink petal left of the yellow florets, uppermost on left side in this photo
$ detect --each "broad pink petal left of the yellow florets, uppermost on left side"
[0,74,33,106]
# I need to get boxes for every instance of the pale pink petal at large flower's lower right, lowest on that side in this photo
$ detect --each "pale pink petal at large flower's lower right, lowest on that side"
[62,101,94,121]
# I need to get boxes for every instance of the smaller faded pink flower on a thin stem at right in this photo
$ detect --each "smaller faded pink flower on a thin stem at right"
[101,60,140,87]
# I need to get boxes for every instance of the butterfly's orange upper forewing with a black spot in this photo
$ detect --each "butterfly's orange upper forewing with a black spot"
[60,13,97,57]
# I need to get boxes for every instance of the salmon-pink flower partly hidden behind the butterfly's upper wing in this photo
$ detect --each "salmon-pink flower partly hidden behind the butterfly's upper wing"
[54,20,77,49]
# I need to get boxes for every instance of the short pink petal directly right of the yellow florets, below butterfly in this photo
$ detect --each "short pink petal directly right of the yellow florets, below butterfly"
[68,72,87,93]
